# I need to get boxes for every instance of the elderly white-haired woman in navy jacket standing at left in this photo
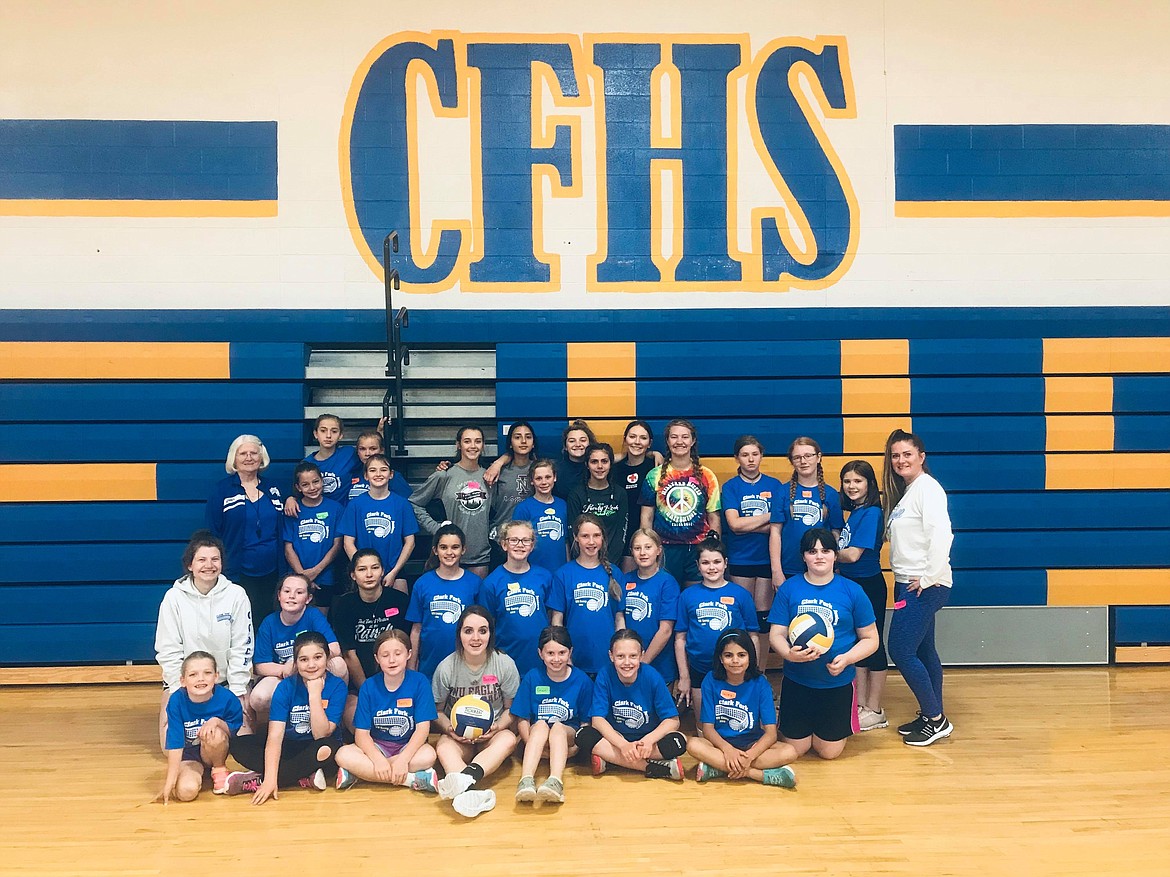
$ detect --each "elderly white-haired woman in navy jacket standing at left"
[206,435,284,627]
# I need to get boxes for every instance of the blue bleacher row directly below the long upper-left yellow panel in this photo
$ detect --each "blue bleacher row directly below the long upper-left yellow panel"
[0,379,305,425]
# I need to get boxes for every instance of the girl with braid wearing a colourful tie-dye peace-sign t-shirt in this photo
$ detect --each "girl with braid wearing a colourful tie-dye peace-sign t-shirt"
[641,420,721,588]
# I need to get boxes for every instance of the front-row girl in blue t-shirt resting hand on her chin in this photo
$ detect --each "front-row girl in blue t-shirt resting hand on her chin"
[227,630,345,805]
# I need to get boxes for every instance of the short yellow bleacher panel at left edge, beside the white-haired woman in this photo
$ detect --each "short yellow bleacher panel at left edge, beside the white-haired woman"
[0,463,158,503]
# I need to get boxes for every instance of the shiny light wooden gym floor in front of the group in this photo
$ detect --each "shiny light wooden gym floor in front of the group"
[0,667,1170,877]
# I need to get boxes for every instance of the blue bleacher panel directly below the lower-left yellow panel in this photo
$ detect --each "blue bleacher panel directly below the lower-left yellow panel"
[0,500,204,545]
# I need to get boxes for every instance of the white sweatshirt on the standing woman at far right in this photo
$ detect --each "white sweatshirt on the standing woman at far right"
[888,472,955,588]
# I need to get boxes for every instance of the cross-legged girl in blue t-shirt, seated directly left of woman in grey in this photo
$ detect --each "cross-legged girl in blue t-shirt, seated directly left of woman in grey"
[337,628,439,792]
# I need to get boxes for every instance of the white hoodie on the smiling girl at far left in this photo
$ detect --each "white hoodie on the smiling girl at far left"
[154,575,255,695]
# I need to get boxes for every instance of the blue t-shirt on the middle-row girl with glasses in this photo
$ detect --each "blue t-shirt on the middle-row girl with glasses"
[479,565,552,676]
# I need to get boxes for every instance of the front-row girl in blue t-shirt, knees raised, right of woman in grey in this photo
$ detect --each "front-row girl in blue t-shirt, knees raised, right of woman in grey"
[512,627,593,803]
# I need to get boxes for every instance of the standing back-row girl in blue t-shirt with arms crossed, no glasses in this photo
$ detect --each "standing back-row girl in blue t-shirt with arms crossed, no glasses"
[722,435,787,654]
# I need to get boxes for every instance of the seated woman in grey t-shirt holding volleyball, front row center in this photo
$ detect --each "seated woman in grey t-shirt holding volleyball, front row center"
[431,606,519,816]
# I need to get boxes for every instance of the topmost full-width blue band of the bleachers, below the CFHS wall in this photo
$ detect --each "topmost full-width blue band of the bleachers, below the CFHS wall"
[0,311,1170,345]
